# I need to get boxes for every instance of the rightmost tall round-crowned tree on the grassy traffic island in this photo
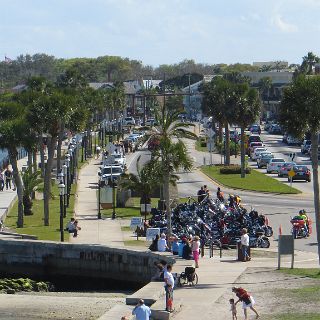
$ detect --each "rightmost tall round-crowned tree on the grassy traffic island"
[231,83,260,178]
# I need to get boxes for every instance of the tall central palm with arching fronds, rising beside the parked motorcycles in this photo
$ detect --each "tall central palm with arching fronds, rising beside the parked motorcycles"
[148,106,197,237]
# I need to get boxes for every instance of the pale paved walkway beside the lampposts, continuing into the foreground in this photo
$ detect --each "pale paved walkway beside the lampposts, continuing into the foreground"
[71,153,319,320]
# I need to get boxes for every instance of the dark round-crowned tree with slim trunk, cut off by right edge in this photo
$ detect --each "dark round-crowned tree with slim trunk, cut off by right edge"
[279,75,320,263]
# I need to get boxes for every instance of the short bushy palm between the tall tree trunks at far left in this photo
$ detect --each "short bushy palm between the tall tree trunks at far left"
[22,168,42,215]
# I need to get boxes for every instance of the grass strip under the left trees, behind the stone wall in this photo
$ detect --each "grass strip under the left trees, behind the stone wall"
[5,185,75,241]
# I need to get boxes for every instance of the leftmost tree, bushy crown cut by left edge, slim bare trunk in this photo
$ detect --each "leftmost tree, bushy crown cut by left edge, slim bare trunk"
[0,101,28,228]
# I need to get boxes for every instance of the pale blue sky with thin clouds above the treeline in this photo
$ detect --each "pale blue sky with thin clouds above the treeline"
[0,0,320,66]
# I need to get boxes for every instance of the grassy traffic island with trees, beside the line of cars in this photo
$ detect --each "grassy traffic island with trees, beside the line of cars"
[201,166,301,194]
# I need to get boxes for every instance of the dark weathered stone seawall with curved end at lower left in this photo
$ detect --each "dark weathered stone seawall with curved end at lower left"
[0,240,175,284]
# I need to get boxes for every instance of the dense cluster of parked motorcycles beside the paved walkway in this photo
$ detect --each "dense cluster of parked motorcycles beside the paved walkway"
[149,196,273,248]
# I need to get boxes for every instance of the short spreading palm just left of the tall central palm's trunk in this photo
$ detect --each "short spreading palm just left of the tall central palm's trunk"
[119,156,160,220]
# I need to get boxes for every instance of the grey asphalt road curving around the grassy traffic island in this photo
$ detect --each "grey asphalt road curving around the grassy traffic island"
[128,134,317,252]
